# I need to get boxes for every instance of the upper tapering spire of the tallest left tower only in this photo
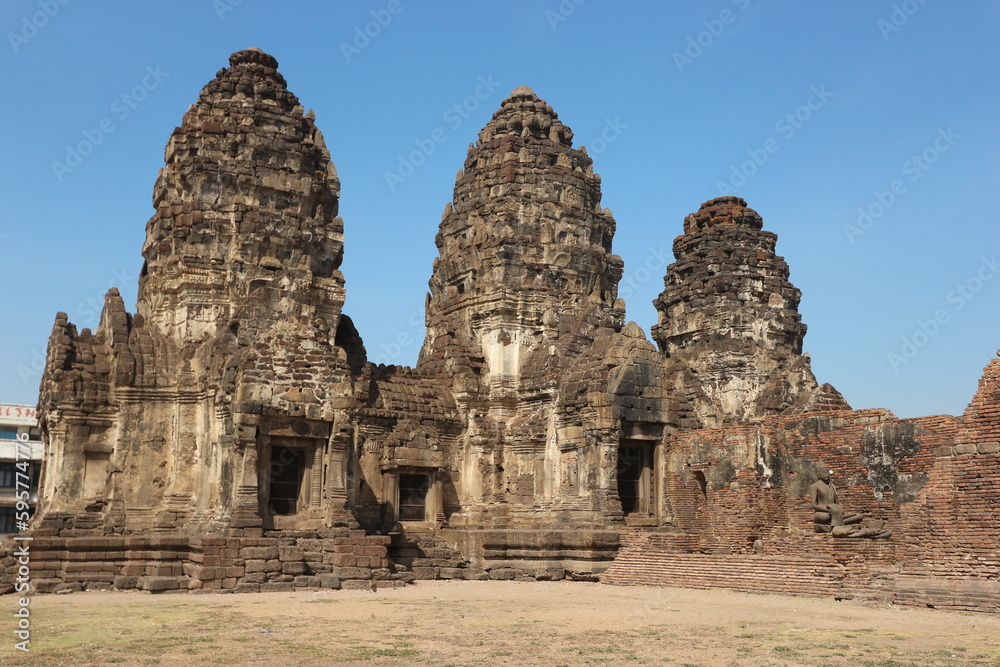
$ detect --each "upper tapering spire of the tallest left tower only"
[138,48,344,339]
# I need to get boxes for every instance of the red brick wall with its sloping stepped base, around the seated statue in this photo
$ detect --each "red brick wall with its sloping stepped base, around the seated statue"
[602,360,1000,612]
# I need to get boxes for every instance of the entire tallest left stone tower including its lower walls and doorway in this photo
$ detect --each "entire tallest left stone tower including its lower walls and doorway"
[40,49,364,534]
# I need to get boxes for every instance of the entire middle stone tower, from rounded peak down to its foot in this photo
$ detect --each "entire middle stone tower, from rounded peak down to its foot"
[417,86,666,528]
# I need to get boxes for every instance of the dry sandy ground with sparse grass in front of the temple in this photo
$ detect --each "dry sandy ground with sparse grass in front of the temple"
[0,581,1000,667]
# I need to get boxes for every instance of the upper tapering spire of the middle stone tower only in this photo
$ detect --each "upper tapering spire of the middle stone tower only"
[420,86,622,384]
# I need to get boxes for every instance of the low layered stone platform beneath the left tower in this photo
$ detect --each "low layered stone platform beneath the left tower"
[0,530,413,593]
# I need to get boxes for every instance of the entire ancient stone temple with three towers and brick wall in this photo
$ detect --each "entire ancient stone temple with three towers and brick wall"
[3,49,1000,611]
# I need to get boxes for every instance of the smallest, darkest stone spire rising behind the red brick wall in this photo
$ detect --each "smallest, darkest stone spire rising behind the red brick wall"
[653,197,848,426]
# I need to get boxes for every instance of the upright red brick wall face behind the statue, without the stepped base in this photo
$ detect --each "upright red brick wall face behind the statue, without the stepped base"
[665,410,1000,564]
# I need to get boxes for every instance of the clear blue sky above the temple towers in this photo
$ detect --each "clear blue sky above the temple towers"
[0,0,1000,417]
